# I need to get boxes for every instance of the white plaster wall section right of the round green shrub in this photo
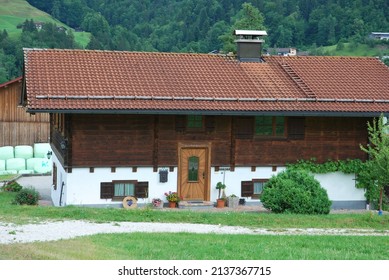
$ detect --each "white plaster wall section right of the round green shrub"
[314,172,366,201]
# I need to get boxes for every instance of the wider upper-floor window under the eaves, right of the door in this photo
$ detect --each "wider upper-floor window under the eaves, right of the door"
[255,116,285,137]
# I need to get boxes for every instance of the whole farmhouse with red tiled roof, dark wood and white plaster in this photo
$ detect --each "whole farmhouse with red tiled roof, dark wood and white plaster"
[22,31,389,208]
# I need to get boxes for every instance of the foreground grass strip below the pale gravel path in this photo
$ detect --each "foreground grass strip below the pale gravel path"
[0,233,389,260]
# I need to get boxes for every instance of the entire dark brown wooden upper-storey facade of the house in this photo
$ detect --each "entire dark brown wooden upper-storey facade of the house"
[51,114,370,168]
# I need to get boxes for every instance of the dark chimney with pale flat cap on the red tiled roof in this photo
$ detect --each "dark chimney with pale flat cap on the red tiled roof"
[234,30,267,62]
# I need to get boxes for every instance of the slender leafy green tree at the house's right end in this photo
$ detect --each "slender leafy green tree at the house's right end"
[358,114,389,211]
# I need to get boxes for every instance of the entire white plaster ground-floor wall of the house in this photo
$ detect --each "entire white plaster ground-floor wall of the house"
[52,161,365,206]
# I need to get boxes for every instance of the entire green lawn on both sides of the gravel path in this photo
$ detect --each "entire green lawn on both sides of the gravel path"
[0,188,389,260]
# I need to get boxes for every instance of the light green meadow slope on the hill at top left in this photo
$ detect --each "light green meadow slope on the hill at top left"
[0,0,90,47]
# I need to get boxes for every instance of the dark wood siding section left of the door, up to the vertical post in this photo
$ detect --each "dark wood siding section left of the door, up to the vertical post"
[69,115,154,167]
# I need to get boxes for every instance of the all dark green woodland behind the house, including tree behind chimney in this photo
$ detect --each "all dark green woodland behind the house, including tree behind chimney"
[0,0,389,83]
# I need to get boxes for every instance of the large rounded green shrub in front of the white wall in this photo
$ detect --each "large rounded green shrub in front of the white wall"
[261,169,331,214]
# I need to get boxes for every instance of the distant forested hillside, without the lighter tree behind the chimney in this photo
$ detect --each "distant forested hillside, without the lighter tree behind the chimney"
[28,0,389,52]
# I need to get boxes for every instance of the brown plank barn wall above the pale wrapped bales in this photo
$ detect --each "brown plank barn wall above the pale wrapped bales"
[0,78,49,146]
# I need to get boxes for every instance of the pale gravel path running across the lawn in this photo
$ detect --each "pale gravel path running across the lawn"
[0,221,389,244]
